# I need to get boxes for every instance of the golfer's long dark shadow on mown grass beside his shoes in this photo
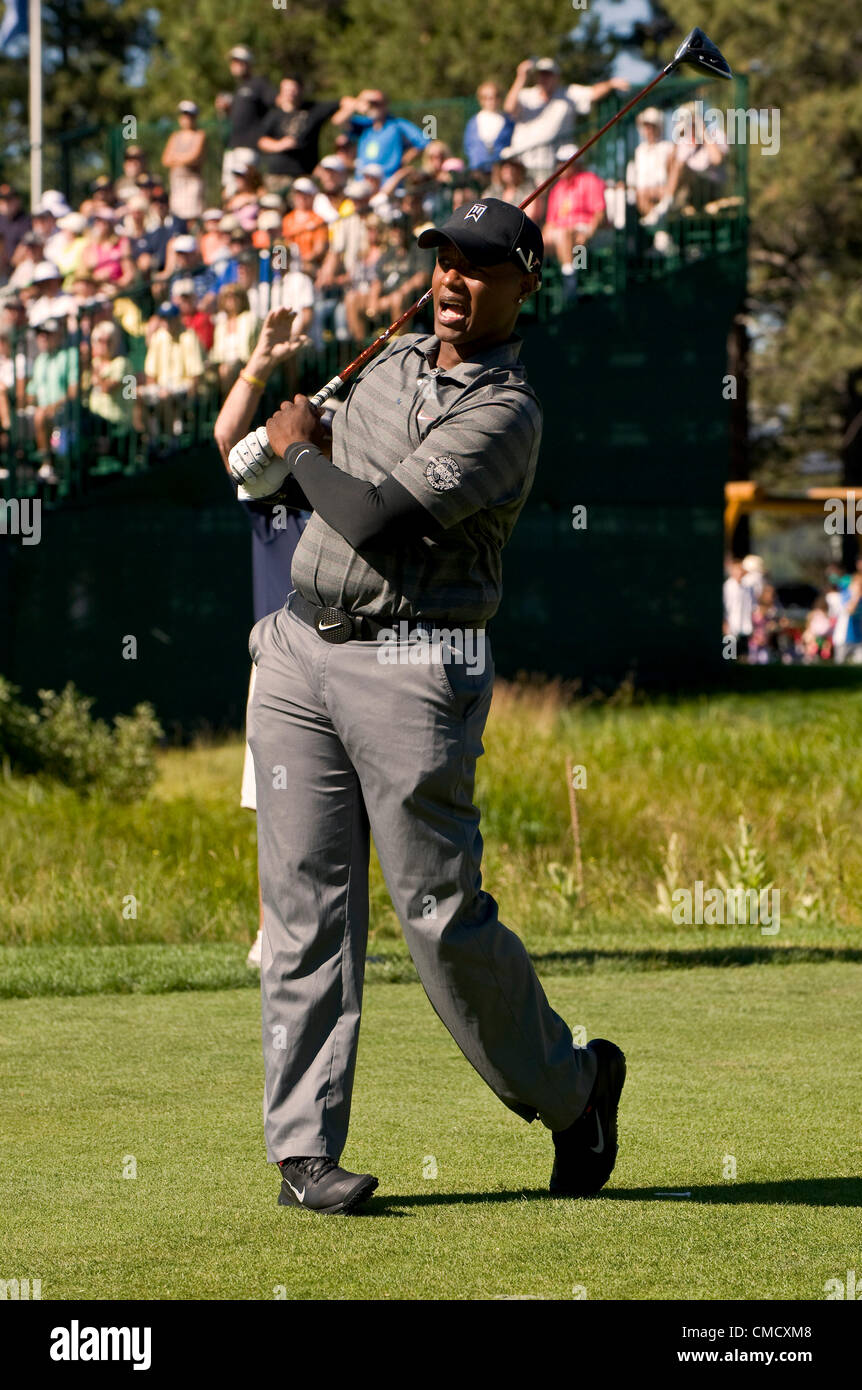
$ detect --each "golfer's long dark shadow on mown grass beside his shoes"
[375,1177,862,1216]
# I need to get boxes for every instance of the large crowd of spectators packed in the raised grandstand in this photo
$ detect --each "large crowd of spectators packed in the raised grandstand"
[0,47,723,485]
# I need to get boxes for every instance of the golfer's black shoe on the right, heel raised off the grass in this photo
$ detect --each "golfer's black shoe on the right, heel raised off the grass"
[551,1038,626,1197]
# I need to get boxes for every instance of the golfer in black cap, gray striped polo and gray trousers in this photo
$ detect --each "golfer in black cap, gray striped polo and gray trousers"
[241,197,626,1212]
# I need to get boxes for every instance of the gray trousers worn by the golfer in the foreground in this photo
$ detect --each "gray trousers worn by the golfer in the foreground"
[247,599,595,1162]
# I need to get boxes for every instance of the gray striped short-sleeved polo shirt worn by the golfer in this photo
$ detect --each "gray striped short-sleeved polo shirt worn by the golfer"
[291,334,542,626]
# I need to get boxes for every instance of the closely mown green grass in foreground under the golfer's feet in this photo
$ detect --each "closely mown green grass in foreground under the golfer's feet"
[0,962,862,1300]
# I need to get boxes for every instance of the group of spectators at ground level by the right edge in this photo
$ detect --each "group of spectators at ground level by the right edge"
[724,555,862,666]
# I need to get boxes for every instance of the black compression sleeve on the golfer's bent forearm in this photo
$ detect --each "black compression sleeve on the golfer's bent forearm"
[284,443,442,550]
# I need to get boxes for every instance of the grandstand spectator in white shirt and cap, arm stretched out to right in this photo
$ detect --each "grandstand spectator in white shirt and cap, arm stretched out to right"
[503,58,628,178]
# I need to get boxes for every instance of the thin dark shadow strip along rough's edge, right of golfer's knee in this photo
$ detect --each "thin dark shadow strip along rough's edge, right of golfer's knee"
[530,945,862,974]
